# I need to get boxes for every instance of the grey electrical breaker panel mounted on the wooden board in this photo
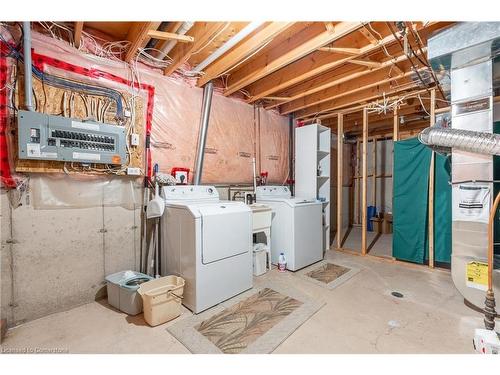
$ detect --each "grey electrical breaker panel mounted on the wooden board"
[18,111,127,164]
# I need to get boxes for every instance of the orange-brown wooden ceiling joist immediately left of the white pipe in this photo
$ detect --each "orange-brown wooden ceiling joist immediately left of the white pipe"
[164,22,226,76]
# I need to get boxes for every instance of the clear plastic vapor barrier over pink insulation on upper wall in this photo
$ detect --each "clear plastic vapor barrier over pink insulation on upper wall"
[3,32,289,195]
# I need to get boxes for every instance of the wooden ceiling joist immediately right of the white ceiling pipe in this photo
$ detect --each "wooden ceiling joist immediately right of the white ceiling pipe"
[197,22,294,87]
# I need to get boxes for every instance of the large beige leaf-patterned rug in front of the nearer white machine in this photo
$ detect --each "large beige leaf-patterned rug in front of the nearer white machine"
[167,283,324,354]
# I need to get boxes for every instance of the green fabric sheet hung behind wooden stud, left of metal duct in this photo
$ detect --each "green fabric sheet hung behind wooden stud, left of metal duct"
[393,138,451,263]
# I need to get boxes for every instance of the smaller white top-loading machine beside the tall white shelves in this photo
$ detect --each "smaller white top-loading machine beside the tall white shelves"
[257,186,323,271]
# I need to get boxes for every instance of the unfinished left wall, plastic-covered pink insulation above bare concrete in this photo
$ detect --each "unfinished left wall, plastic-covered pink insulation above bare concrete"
[0,33,289,326]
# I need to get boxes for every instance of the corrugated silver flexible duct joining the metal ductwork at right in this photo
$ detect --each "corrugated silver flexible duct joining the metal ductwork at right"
[418,127,500,155]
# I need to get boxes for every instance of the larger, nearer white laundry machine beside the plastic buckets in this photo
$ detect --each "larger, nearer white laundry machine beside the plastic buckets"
[161,185,253,314]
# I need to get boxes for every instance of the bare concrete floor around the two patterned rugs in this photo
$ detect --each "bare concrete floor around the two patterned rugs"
[2,251,482,353]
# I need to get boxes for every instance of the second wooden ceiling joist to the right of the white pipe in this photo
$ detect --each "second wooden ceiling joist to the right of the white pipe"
[224,22,361,96]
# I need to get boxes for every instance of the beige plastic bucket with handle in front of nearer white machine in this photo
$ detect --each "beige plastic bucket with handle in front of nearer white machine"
[137,275,185,326]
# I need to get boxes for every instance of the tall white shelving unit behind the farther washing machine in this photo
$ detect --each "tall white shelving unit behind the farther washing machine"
[295,124,331,251]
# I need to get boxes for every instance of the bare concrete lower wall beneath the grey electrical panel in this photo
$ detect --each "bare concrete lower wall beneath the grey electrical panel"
[0,181,141,326]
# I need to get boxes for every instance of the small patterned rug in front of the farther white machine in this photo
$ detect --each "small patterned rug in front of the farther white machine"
[299,261,359,289]
